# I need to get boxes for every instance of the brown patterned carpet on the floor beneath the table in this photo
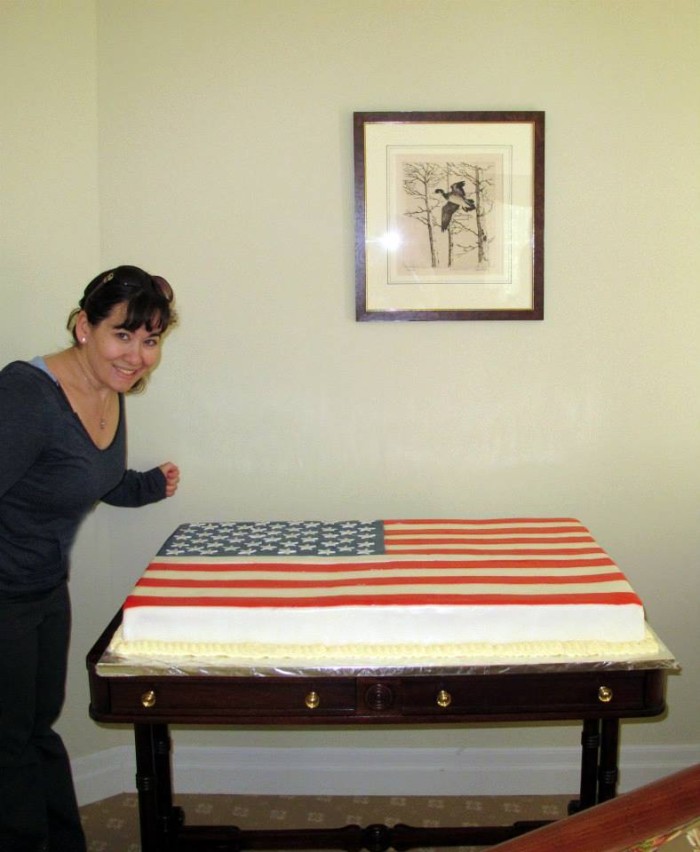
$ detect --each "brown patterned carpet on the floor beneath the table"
[81,794,573,852]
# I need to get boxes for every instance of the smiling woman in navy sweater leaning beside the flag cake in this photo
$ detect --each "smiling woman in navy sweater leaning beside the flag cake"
[0,266,180,852]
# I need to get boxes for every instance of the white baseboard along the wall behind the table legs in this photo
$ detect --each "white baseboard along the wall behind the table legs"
[73,745,700,805]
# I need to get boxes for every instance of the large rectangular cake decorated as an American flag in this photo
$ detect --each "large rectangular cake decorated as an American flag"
[117,518,645,647]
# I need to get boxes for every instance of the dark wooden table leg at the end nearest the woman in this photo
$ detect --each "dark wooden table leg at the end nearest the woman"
[134,723,182,852]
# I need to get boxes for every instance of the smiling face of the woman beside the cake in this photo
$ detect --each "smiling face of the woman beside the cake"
[76,303,161,393]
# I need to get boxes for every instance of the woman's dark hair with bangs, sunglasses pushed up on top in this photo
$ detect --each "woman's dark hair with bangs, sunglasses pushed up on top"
[67,266,177,392]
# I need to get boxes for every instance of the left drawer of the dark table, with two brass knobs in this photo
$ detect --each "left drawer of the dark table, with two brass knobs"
[110,678,356,719]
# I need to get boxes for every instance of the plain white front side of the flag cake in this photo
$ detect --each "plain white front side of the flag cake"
[123,604,645,646]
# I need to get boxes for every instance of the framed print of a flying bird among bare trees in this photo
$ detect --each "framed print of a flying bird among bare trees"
[354,112,544,321]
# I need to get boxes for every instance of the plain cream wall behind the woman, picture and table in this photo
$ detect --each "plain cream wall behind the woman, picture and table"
[0,0,700,768]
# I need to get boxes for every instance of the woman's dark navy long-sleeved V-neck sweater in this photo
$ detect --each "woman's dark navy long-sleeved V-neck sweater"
[0,361,165,597]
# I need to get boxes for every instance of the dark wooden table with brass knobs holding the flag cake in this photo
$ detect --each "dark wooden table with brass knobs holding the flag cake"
[87,613,677,852]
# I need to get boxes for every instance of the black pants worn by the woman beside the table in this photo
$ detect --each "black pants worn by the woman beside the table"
[0,584,86,852]
